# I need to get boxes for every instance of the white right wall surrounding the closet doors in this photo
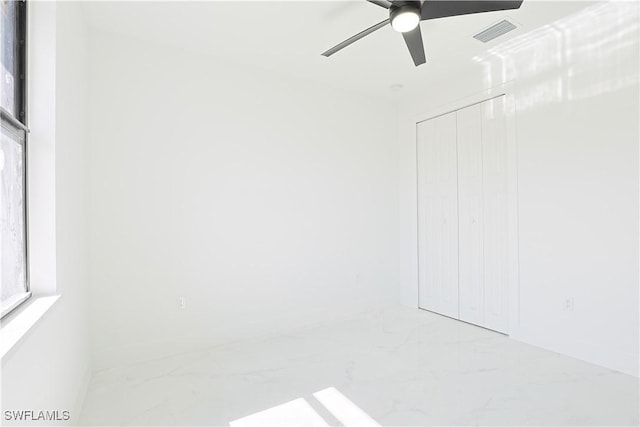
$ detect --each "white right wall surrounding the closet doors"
[399,2,640,375]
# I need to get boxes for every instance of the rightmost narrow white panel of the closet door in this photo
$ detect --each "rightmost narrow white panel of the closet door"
[481,96,509,333]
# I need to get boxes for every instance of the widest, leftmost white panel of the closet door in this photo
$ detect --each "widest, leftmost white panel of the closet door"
[417,113,458,318]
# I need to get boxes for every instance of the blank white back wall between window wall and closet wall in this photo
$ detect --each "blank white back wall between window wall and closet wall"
[89,32,398,368]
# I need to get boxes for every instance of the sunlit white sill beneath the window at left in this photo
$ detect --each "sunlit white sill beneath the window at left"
[0,295,60,359]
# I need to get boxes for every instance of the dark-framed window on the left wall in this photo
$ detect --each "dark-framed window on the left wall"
[0,0,30,316]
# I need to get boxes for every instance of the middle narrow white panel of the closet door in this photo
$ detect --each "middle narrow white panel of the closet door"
[456,104,484,325]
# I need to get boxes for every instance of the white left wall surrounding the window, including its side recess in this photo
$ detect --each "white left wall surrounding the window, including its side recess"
[2,2,90,423]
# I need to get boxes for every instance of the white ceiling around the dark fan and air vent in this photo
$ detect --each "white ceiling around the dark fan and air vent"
[84,0,593,99]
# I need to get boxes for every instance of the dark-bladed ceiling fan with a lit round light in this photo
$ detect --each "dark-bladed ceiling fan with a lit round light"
[322,0,522,67]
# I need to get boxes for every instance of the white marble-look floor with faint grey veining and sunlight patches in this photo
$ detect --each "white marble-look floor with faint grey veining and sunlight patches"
[80,308,639,427]
